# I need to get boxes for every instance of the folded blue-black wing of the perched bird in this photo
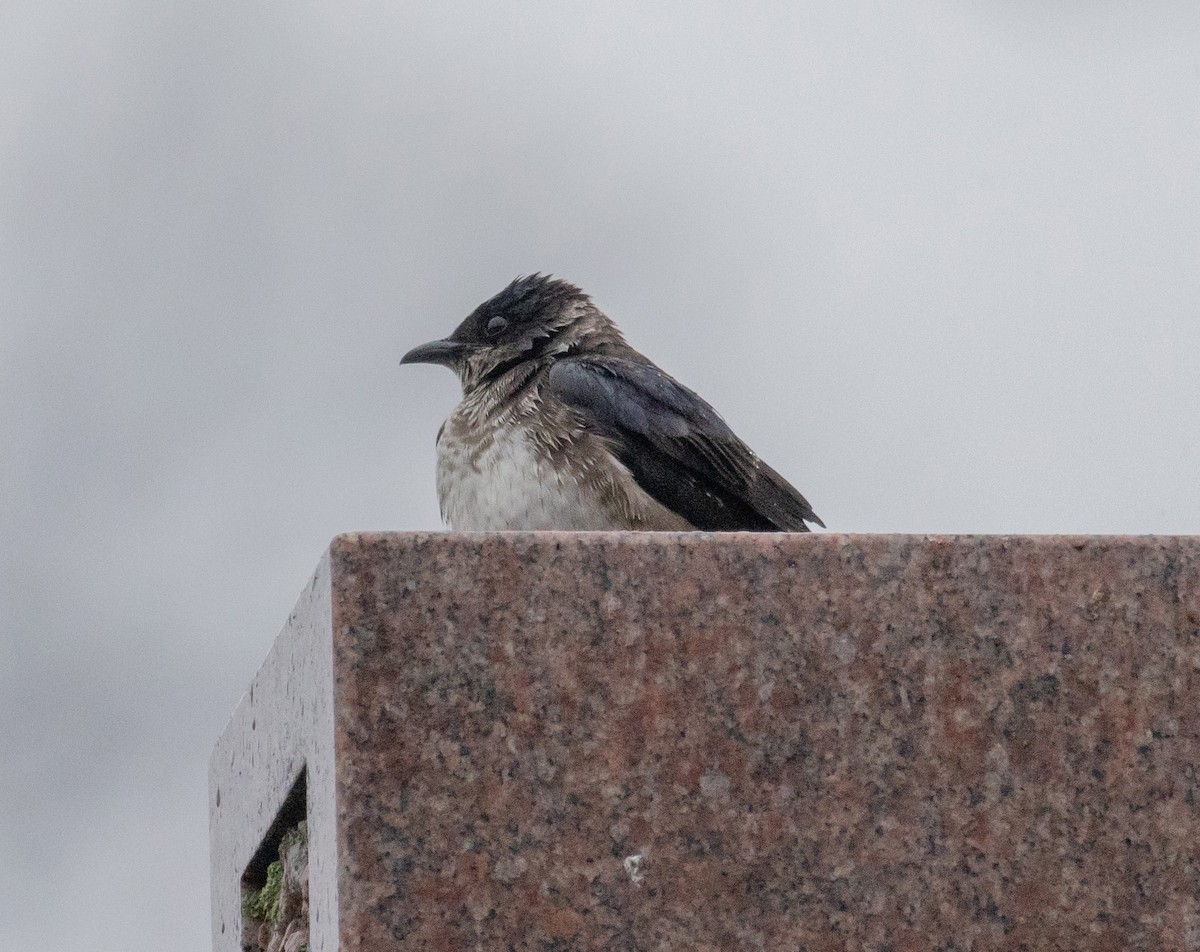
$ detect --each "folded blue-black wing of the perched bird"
[546,355,824,532]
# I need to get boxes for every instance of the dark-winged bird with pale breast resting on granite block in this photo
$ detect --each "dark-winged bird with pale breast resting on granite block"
[400,273,824,532]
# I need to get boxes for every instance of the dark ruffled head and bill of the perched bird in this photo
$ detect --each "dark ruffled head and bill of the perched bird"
[400,274,624,393]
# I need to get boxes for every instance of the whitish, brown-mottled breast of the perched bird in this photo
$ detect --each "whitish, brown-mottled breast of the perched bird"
[438,419,622,532]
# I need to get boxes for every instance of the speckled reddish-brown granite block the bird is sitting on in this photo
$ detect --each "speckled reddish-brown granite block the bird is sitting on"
[214,533,1200,952]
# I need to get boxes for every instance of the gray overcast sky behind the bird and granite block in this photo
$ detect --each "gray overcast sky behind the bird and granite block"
[0,0,1200,952]
